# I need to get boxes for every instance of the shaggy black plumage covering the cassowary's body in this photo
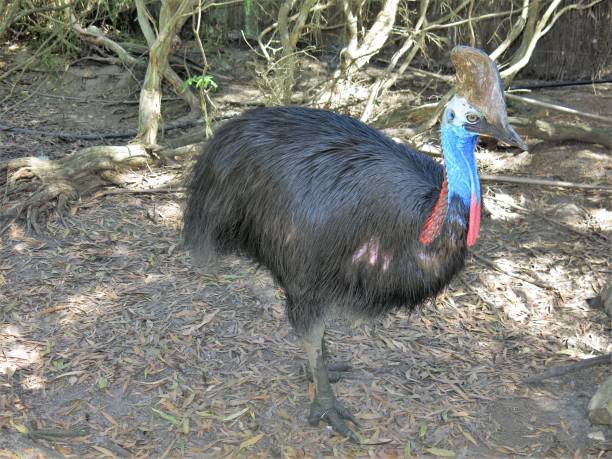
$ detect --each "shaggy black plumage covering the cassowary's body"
[184,107,467,334]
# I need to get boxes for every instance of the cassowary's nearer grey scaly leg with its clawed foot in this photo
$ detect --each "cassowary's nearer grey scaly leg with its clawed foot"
[303,324,359,443]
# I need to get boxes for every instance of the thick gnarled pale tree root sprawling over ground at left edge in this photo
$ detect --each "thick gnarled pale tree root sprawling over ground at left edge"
[0,145,153,234]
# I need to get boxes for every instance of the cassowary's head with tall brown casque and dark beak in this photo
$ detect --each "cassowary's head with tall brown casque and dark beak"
[442,46,527,150]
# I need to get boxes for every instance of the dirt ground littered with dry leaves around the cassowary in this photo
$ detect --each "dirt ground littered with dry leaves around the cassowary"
[0,49,612,458]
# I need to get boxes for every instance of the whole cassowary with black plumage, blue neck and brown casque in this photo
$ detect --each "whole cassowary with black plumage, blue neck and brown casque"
[183,46,526,441]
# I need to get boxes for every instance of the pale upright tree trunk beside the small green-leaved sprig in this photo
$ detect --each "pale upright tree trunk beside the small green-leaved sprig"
[135,0,195,146]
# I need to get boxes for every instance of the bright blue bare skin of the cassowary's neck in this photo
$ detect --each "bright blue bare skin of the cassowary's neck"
[440,123,480,209]
